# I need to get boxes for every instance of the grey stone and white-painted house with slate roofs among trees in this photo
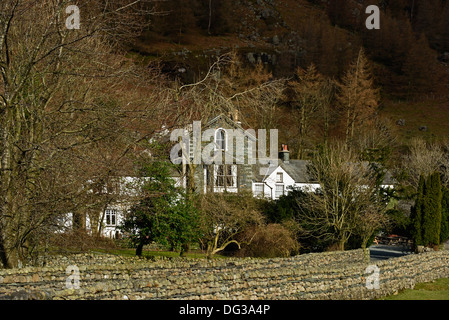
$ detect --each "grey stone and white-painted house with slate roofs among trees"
[64,115,393,238]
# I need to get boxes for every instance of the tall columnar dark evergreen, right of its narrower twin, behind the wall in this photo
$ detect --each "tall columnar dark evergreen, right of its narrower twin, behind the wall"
[422,173,442,246]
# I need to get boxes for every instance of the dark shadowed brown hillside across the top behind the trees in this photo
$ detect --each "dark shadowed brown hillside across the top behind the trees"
[125,0,449,147]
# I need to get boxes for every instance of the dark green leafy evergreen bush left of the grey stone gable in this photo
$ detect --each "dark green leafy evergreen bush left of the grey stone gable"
[120,162,199,255]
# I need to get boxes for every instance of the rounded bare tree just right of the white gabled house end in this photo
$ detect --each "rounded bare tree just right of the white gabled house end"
[299,143,385,250]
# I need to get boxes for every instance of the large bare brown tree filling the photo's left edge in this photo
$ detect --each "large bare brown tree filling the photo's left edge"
[0,0,164,267]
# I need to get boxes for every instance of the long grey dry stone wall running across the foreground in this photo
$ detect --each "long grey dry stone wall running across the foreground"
[0,250,449,300]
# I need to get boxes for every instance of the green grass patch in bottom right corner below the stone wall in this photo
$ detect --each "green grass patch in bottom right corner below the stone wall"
[382,278,449,300]
